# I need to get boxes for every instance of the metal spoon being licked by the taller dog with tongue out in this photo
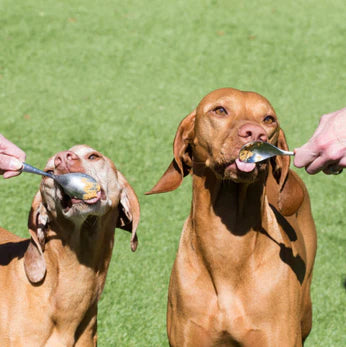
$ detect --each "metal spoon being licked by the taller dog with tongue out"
[239,141,294,163]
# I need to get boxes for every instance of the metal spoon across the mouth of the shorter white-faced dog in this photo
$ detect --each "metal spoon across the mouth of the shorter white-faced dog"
[21,163,101,200]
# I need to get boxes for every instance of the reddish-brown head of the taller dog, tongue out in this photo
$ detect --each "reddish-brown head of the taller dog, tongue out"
[147,88,302,212]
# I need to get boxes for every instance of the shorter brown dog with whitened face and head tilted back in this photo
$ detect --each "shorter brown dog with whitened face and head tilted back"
[0,145,139,347]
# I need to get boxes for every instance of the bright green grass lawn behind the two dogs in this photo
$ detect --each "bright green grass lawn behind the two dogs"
[0,0,346,346]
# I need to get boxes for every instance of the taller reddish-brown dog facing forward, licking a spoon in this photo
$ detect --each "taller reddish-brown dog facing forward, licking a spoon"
[148,88,316,347]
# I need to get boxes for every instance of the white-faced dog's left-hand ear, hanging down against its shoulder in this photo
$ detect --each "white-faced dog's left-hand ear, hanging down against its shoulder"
[24,191,49,283]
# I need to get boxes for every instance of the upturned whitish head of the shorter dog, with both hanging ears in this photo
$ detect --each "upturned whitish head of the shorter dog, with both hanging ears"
[24,145,140,283]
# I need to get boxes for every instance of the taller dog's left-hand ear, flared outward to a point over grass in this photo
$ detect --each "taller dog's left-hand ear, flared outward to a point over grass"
[145,110,196,195]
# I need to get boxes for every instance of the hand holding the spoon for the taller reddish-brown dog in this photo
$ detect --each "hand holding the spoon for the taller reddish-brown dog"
[294,107,346,174]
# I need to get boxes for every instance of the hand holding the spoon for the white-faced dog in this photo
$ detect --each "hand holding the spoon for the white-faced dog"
[0,134,26,178]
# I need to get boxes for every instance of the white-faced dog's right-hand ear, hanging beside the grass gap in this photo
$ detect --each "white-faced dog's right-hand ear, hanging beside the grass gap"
[117,171,140,252]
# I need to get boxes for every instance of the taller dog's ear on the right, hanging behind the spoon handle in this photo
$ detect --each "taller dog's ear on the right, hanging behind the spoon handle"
[271,129,304,216]
